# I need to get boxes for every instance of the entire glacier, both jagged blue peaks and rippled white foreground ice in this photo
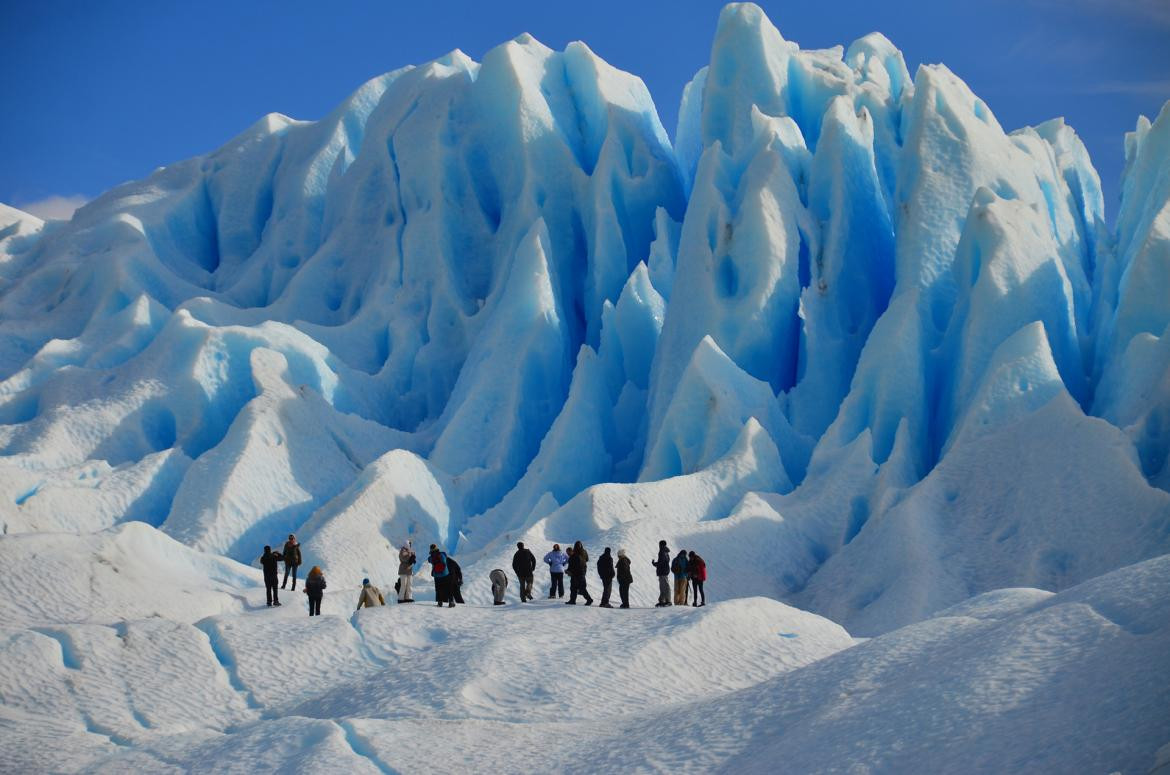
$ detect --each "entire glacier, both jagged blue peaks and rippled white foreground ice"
[0,4,1170,771]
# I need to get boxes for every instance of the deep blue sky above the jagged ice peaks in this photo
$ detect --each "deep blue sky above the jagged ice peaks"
[0,0,1170,218]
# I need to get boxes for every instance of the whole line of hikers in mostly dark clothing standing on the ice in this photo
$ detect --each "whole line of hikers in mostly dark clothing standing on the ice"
[260,534,707,616]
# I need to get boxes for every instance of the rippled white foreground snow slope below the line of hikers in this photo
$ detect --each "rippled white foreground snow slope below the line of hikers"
[0,527,1170,773]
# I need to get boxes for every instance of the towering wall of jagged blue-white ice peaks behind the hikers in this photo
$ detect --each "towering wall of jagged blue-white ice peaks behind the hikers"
[0,4,1170,650]
